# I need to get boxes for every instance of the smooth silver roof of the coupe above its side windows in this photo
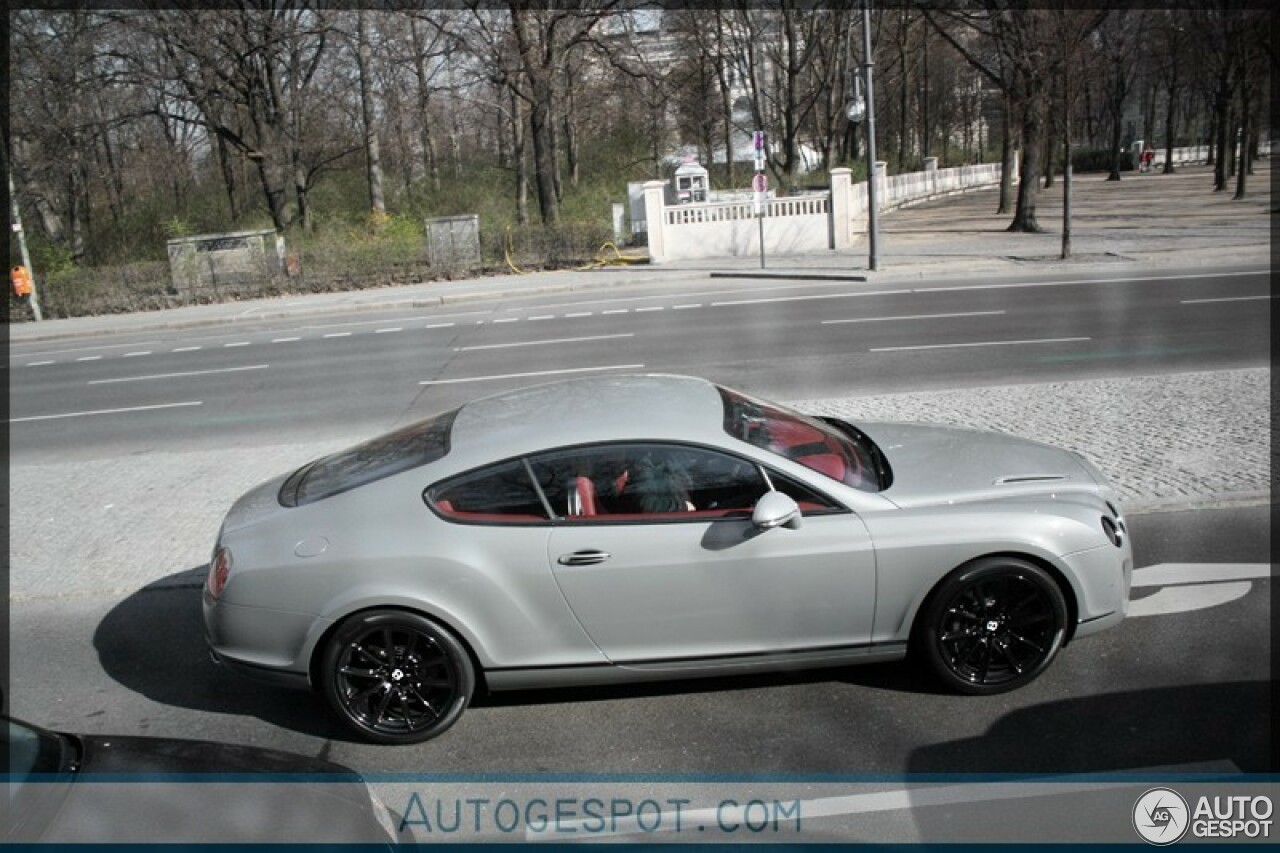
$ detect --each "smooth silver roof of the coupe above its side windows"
[449,374,724,460]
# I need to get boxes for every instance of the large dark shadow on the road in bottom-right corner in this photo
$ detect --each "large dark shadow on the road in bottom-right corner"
[906,681,1276,845]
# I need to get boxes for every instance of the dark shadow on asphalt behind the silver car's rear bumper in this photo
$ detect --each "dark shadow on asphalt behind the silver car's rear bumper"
[93,566,353,740]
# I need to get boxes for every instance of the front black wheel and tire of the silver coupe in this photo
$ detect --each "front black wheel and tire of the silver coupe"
[914,558,1068,695]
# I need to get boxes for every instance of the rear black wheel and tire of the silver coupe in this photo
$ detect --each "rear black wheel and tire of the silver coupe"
[320,610,475,744]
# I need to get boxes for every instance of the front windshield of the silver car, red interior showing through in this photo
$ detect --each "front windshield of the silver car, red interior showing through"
[719,388,887,492]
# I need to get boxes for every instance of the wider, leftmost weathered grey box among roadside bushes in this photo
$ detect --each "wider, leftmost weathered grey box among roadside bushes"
[168,229,284,295]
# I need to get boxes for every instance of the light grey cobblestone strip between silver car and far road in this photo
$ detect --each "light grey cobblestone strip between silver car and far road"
[9,368,1271,601]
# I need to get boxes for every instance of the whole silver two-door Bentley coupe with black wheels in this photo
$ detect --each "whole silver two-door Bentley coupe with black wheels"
[204,375,1133,743]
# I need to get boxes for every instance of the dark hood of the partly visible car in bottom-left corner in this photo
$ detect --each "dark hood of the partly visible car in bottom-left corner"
[26,736,394,844]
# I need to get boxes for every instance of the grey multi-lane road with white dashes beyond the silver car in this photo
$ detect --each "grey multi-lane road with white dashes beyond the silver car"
[9,269,1271,461]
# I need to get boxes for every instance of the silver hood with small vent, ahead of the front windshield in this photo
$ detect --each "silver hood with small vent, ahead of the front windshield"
[858,423,1100,507]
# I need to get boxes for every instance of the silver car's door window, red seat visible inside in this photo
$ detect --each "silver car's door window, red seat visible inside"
[530,444,768,521]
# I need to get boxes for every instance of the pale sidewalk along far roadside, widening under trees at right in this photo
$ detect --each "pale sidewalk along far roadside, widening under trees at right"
[8,161,1271,343]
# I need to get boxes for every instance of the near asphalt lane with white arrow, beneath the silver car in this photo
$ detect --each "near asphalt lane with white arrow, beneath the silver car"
[10,507,1274,777]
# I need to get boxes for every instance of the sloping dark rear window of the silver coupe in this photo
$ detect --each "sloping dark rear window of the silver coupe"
[280,409,458,506]
